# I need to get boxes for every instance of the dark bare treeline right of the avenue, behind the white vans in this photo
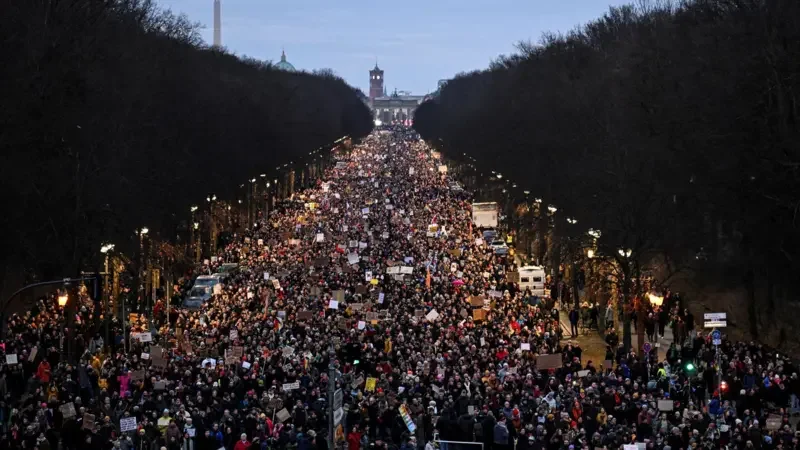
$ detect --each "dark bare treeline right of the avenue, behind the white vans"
[415,0,800,342]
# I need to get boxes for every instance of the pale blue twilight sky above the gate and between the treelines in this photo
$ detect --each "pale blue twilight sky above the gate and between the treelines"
[156,0,630,94]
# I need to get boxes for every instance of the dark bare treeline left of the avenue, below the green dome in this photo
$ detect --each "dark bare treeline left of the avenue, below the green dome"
[0,0,372,292]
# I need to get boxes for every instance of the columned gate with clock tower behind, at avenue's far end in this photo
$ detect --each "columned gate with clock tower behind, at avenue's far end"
[368,63,425,125]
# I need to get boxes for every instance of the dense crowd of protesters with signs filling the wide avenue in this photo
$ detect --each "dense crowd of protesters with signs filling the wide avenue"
[0,132,800,450]
